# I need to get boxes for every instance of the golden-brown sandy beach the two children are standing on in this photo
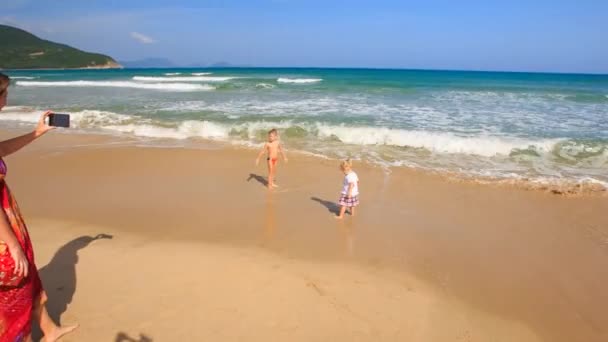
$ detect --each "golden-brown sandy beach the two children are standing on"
[0,129,608,342]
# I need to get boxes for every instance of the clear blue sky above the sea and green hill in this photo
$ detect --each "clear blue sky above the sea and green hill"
[0,0,608,74]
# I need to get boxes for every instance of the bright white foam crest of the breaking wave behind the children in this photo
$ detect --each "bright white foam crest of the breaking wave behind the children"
[94,121,561,157]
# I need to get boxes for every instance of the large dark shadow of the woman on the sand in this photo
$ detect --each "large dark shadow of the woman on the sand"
[35,234,113,332]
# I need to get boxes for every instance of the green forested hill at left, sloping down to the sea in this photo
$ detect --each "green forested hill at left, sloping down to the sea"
[0,25,121,69]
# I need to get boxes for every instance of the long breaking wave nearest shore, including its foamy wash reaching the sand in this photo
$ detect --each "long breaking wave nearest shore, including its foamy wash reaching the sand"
[0,107,608,193]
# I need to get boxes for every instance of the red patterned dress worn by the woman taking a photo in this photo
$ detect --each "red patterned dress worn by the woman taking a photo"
[0,158,44,342]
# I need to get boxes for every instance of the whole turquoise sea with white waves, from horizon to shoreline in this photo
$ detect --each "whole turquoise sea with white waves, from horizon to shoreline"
[1,68,608,188]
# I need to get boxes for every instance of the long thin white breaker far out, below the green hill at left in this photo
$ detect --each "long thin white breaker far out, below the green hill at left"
[17,81,215,91]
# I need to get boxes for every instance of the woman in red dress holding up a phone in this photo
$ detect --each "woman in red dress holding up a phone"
[0,73,76,342]
